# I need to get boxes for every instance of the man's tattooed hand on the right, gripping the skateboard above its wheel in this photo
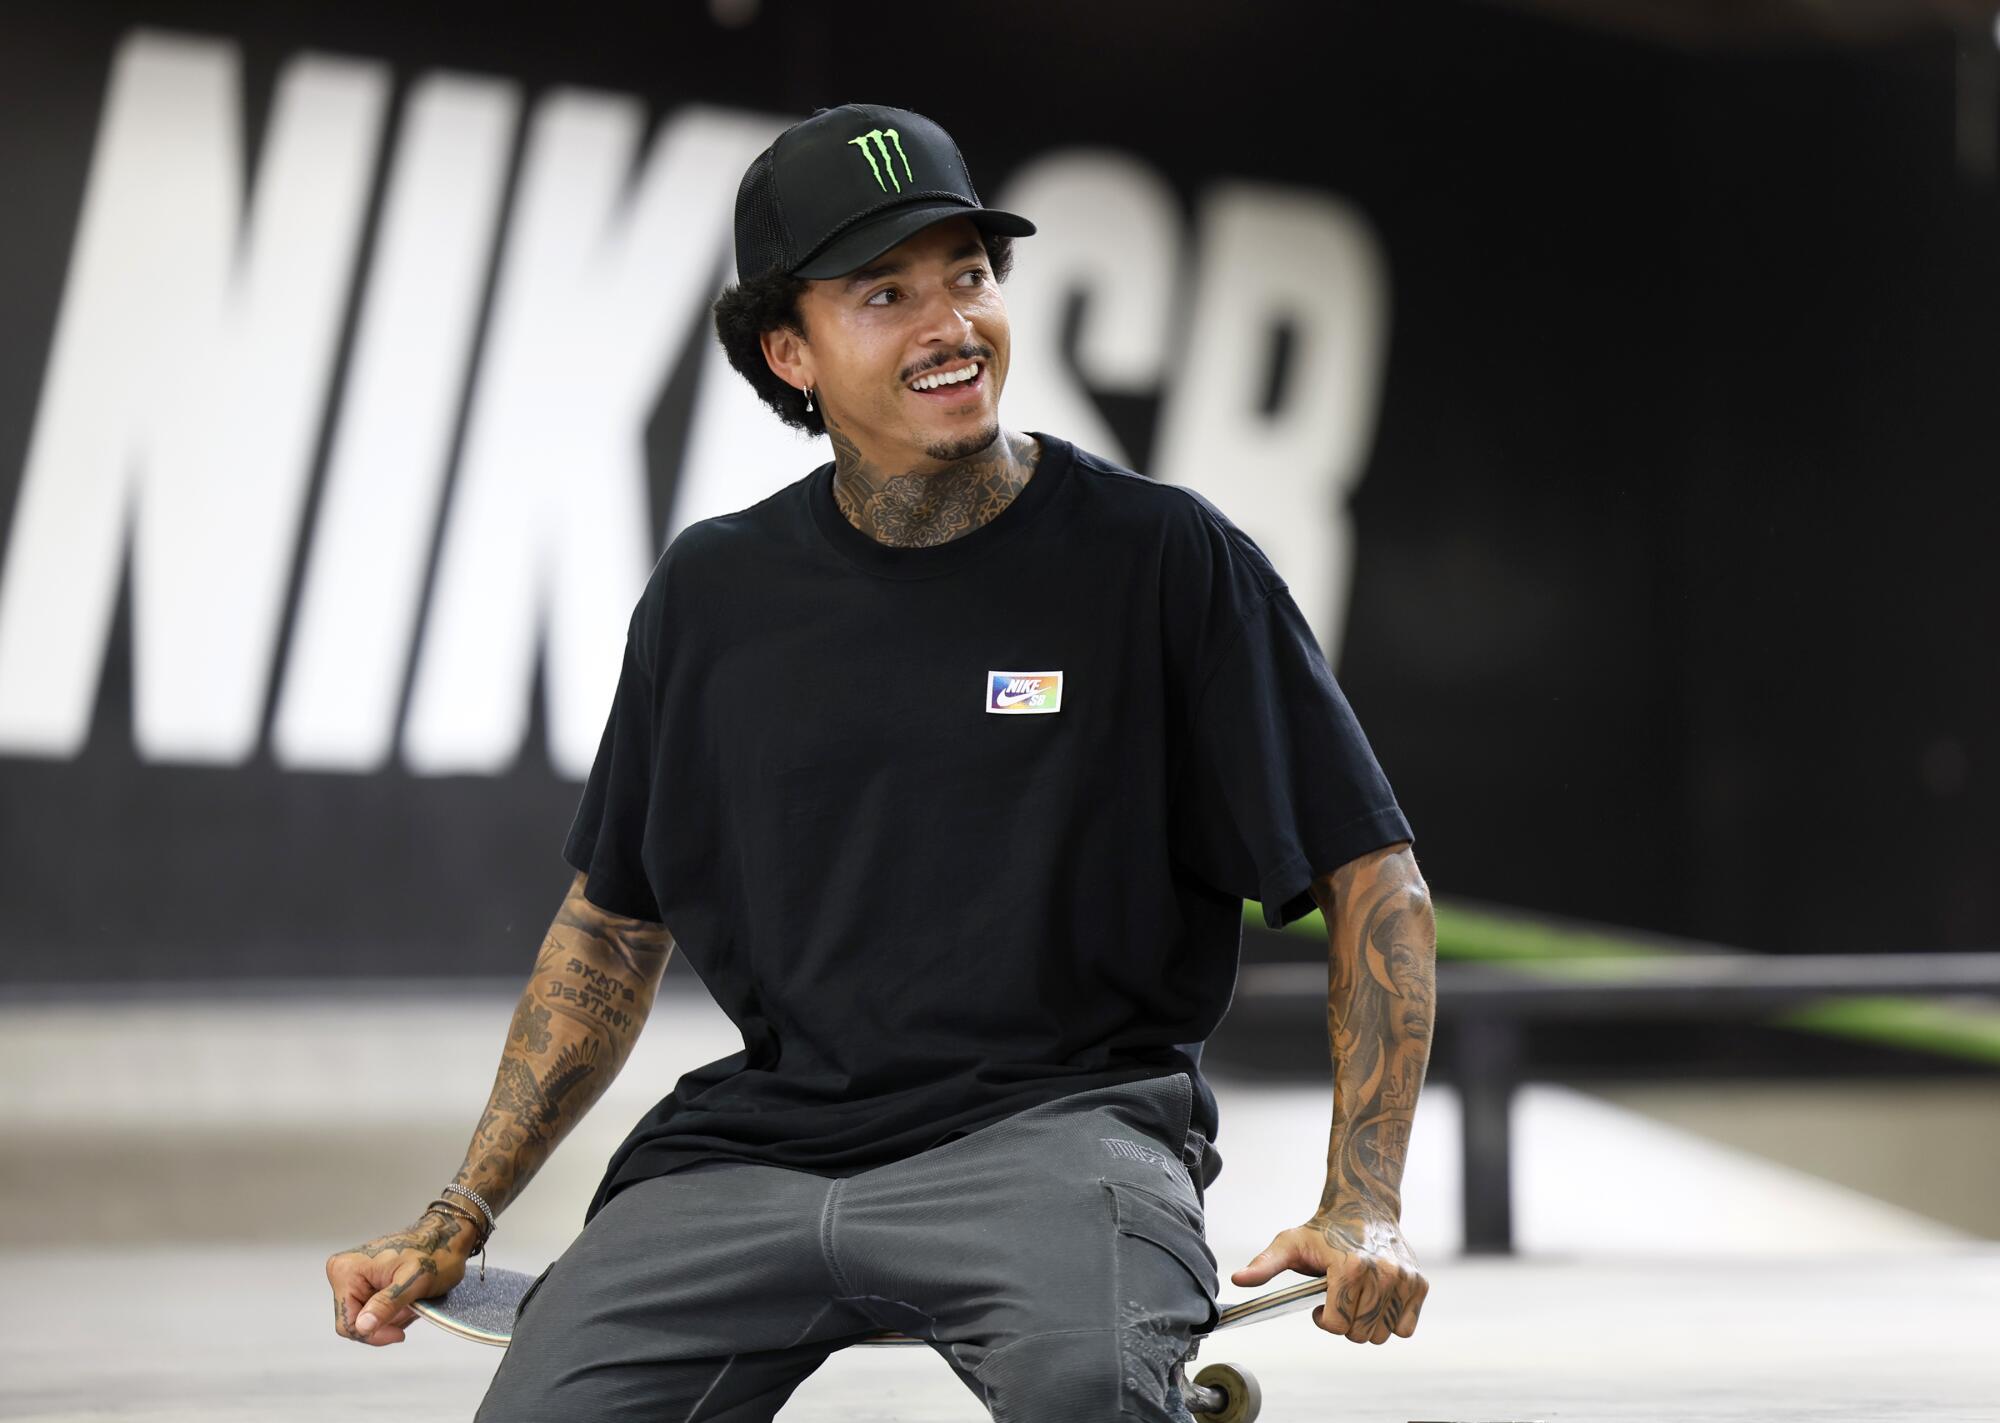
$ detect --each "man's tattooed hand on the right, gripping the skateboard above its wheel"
[1230,1213,1430,1343]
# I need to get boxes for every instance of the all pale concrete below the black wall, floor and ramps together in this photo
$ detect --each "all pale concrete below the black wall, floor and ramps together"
[0,989,2000,1423]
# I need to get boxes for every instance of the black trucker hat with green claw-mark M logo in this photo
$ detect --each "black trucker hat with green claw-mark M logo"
[736,104,1034,282]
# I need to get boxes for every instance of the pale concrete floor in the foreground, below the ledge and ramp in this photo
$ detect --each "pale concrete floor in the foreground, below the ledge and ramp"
[0,1245,2000,1423]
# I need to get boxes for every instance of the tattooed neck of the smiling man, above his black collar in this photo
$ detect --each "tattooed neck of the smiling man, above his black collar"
[826,420,1042,548]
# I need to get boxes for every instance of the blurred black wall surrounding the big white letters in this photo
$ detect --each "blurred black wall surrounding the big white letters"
[0,2,2000,981]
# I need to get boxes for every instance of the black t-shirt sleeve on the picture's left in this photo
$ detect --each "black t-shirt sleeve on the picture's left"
[562,610,660,921]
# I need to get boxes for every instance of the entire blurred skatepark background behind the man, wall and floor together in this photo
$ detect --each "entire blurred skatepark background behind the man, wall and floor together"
[0,0,2000,1419]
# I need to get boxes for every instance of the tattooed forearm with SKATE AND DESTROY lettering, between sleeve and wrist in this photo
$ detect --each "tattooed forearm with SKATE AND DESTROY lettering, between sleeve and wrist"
[452,875,674,1213]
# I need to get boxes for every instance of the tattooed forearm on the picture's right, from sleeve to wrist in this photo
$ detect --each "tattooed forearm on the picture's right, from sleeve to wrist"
[1312,847,1438,1251]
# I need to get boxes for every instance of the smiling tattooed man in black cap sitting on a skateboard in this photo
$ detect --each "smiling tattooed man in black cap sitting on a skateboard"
[328,106,1434,1423]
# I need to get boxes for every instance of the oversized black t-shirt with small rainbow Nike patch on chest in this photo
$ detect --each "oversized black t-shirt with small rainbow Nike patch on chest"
[564,436,1410,1213]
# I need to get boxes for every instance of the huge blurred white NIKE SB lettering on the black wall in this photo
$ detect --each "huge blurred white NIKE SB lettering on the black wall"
[0,30,1388,779]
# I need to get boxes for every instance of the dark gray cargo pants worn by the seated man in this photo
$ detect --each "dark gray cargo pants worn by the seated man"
[478,1073,1218,1423]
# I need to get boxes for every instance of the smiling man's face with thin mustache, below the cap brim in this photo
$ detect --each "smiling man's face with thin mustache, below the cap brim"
[800,218,1008,470]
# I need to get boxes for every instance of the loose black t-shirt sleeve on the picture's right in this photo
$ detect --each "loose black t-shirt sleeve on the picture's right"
[1176,580,1410,929]
